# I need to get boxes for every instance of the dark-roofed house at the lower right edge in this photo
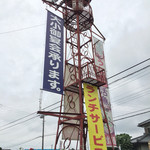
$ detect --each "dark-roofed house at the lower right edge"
[131,119,150,150]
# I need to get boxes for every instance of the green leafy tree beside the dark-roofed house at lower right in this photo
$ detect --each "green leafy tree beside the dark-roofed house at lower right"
[116,133,133,150]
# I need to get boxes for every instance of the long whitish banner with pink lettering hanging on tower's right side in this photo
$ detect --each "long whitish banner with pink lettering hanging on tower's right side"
[92,37,116,147]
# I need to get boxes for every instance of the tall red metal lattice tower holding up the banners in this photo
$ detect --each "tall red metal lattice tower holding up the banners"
[38,0,113,150]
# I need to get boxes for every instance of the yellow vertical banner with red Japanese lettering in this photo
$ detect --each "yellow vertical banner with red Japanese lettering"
[83,83,107,150]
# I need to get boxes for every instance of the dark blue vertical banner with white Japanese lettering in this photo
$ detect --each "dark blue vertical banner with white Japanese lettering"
[43,11,63,94]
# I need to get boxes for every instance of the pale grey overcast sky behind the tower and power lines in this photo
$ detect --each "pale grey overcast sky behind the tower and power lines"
[0,0,150,150]
